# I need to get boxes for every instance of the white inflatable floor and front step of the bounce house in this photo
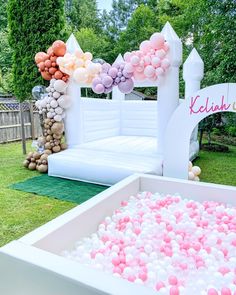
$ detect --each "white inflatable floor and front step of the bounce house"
[49,136,198,185]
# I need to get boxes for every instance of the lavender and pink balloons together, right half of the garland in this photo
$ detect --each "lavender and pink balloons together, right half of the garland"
[92,33,170,94]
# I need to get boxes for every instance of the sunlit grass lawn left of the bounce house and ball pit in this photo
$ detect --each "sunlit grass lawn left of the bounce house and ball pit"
[0,143,75,246]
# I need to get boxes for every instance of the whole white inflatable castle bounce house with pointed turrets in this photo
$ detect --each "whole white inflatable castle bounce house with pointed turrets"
[49,23,204,185]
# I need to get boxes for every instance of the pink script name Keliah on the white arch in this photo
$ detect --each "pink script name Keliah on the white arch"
[189,95,236,115]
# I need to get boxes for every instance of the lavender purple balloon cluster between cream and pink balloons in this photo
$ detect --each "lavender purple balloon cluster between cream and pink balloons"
[92,62,134,94]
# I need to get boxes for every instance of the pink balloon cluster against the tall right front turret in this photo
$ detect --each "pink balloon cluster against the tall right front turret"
[124,33,170,81]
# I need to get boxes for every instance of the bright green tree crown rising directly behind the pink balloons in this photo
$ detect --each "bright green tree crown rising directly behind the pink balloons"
[117,4,159,54]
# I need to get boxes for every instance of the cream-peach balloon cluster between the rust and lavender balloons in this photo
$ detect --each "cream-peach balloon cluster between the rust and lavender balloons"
[57,50,101,84]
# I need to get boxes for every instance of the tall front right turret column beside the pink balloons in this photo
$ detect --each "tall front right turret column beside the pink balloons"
[157,22,182,154]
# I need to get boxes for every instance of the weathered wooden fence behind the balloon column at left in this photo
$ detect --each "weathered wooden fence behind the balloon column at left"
[0,100,42,143]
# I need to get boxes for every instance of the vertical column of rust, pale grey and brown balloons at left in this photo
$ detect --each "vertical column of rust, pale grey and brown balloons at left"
[23,40,70,173]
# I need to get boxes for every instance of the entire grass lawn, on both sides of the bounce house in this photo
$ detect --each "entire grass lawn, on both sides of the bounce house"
[0,143,236,246]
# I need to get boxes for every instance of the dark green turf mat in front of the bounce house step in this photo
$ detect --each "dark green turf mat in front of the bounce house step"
[10,174,107,204]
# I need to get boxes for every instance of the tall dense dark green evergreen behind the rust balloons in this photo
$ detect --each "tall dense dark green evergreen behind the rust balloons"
[8,0,65,101]
